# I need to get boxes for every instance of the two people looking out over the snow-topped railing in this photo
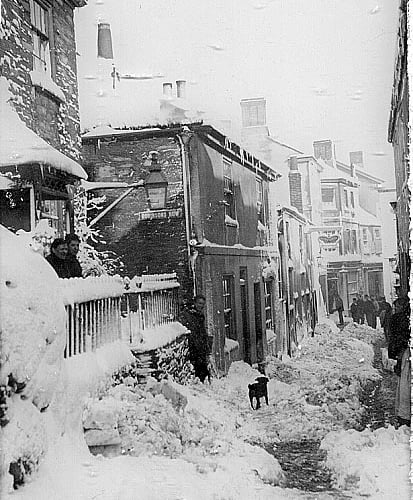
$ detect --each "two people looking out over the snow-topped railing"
[46,234,82,278]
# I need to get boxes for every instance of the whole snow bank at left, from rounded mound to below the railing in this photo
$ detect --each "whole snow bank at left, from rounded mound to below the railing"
[0,226,133,492]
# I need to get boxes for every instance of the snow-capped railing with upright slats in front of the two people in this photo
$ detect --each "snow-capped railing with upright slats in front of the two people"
[61,273,179,358]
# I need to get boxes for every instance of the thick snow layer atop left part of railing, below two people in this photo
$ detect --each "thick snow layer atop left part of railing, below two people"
[60,276,124,305]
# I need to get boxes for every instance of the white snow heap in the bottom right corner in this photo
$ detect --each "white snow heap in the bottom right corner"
[321,426,410,500]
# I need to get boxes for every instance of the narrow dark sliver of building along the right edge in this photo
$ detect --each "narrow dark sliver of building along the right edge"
[388,0,410,294]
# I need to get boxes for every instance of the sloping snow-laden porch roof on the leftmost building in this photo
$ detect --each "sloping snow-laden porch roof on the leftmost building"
[0,77,87,179]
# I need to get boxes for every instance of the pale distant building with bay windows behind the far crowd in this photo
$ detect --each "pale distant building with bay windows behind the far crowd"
[314,140,384,312]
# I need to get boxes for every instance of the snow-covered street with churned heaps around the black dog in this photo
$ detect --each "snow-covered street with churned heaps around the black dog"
[3,314,409,500]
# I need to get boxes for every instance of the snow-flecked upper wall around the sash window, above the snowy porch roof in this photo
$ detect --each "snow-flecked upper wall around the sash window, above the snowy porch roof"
[0,0,80,159]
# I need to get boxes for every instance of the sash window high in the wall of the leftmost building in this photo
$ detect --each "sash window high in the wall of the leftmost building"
[30,0,51,76]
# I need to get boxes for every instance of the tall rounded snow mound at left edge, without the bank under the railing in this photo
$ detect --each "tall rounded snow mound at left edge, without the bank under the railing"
[0,226,66,496]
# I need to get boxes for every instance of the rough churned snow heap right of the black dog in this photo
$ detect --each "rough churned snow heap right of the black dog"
[260,325,380,439]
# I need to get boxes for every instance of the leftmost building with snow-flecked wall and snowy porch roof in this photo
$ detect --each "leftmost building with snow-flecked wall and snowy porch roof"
[0,0,86,234]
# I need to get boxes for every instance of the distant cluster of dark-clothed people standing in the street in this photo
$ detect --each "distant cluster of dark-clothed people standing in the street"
[350,294,392,332]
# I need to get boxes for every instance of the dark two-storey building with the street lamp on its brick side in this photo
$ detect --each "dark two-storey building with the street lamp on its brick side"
[83,124,277,372]
